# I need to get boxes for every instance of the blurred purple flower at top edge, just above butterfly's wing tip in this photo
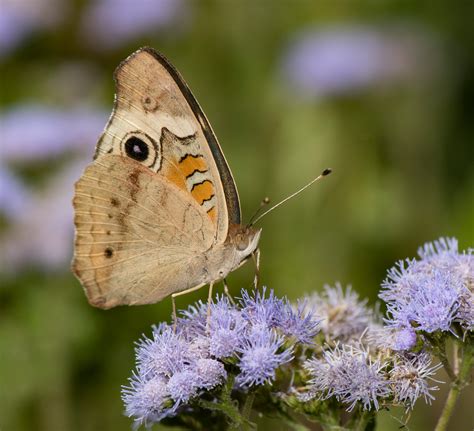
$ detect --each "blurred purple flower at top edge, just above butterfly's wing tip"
[81,0,189,48]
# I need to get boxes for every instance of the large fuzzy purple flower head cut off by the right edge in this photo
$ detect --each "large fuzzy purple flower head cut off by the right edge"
[379,238,474,333]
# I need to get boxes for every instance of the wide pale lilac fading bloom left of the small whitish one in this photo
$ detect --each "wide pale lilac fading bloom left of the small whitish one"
[302,343,390,411]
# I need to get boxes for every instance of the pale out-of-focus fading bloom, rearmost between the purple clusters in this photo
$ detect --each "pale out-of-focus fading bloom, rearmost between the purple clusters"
[308,283,373,341]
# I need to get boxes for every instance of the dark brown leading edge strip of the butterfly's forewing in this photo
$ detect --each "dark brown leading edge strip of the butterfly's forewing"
[124,47,241,224]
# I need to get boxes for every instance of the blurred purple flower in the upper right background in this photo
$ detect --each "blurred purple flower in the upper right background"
[282,26,440,97]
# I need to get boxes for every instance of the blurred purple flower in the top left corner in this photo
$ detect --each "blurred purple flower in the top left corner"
[0,0,68,57]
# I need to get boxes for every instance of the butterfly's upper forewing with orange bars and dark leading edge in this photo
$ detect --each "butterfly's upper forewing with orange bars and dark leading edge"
[96,48,241,243]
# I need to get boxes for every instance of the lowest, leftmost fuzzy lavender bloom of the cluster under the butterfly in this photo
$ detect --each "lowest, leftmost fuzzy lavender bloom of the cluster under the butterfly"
[122,374,174,426]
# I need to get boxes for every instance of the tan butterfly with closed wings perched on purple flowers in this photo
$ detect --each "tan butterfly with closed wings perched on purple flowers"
[72,47,261,309]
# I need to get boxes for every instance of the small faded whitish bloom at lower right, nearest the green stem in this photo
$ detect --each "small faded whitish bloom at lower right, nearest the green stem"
[390,353,442,409]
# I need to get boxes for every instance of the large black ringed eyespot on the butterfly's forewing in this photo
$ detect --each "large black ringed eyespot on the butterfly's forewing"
[122,131,161,171]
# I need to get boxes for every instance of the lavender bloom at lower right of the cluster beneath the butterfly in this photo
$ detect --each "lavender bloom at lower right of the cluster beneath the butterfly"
[237,327,293,387]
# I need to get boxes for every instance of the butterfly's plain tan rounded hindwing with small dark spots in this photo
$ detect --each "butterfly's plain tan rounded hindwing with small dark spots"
[73,155,215,308]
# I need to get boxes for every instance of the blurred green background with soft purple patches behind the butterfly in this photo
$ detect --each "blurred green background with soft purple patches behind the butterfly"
[0,0,474,431]
